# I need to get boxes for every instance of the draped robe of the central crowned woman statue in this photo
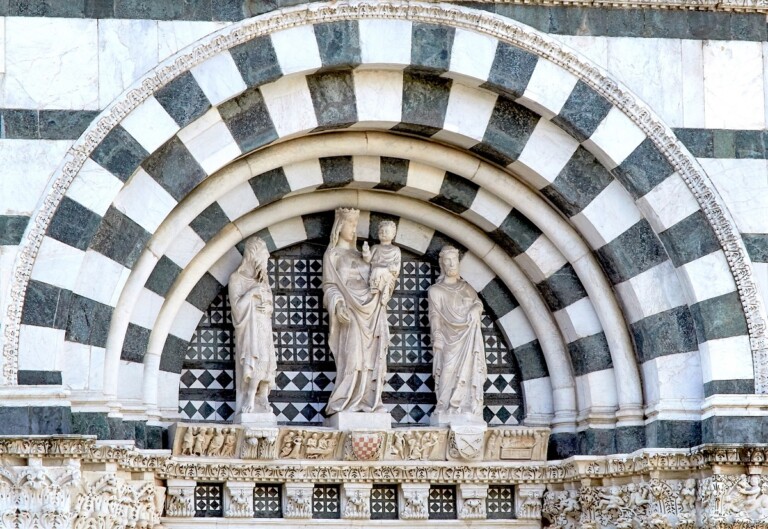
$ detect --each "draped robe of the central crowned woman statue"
[323,248,389,414]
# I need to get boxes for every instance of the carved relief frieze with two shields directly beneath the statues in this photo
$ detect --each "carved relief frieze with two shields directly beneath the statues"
[169,423,550,461]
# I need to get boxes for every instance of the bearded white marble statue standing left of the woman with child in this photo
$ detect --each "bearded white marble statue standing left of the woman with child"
[229,237,277,416]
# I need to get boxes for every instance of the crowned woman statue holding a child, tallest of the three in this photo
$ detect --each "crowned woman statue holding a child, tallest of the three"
[323,208,399,415]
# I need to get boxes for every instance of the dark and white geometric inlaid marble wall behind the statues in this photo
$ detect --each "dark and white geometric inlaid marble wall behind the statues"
[179,244,521,425]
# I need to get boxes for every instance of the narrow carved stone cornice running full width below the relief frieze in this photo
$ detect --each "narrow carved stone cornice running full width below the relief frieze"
[0,436,768,484]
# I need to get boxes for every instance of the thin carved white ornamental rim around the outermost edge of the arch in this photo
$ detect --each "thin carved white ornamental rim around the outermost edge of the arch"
[3,0,768,393]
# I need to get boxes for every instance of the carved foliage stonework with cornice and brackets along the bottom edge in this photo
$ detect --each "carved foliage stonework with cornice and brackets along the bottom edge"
[0,438,768,529]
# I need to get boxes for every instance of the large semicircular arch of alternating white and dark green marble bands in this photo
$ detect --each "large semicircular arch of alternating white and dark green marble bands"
[4,3,764,455]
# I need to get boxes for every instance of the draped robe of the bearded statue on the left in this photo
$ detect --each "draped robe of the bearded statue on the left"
[229,270,277,409]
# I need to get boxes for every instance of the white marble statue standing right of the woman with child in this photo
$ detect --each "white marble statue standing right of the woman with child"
[428,246,487,424]
